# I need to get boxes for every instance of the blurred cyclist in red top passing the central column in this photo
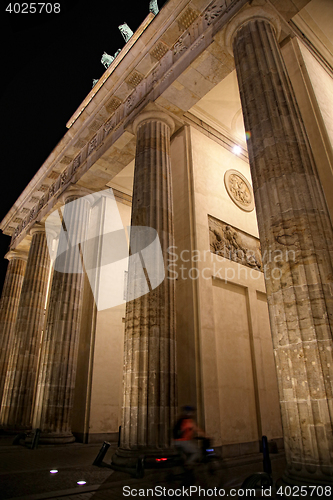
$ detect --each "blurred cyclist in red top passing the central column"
[173,406,205,465]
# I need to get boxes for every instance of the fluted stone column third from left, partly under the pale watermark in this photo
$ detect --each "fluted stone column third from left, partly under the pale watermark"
[33,188,90,443]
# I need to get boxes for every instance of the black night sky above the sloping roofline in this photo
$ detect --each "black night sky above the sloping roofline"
[0,0,167,290]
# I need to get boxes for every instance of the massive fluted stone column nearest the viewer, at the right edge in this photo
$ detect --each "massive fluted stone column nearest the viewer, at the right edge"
[233,19,333,485]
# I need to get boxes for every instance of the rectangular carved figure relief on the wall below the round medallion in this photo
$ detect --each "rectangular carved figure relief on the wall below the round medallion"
[208,215,263,272]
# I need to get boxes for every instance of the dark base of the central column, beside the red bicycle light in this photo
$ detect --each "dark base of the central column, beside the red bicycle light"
[111,447,179,477]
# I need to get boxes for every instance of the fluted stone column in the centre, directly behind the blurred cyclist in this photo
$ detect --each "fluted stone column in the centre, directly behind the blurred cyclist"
[112,111,176,467]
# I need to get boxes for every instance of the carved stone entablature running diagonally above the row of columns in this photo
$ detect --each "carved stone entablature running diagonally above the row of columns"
[1,0,306,248]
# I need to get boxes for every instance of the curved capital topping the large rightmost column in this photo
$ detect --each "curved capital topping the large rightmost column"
[224,4,281,57]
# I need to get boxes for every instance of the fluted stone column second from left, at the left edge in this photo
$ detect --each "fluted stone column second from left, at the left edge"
[0,223,50,430]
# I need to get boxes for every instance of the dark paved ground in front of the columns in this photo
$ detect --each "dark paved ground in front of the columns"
[0,437,285,500]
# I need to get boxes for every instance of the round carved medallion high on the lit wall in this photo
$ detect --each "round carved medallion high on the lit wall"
[224,170,254,212]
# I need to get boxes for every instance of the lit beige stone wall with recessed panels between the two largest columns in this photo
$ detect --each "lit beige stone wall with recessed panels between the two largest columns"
[171,127,282,456]
